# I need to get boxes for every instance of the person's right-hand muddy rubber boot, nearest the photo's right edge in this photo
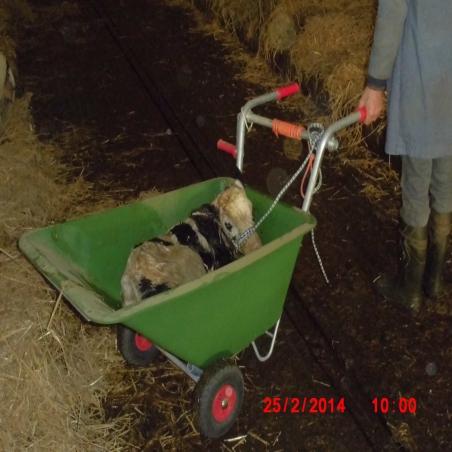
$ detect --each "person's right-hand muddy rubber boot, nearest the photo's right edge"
[423,209,452,300]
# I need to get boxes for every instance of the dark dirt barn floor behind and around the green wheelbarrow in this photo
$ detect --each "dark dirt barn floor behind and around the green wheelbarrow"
[14,0,452,452]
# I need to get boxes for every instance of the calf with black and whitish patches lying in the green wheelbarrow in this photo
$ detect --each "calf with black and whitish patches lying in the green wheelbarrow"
[121,181,262,306]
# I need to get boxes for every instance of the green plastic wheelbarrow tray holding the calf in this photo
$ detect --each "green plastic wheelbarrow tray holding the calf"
[19,178,316,368]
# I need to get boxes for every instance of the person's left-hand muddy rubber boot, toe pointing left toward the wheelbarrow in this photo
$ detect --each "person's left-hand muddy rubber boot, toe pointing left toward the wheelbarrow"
[375,220,427,314]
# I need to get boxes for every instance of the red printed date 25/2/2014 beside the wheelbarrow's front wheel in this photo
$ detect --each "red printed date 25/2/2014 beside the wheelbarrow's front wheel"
[263,397,345,414]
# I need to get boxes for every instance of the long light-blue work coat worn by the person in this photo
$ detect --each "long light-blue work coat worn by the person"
[369,0,452,158]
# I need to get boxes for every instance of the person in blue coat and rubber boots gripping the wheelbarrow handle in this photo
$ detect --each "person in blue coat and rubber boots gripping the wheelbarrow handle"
[358,0,452,313]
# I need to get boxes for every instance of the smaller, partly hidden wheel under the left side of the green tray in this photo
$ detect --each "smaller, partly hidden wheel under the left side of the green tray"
[116,325,159,367]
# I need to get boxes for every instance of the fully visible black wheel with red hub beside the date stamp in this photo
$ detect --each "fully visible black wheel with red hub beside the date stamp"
[193,359,243,438]
